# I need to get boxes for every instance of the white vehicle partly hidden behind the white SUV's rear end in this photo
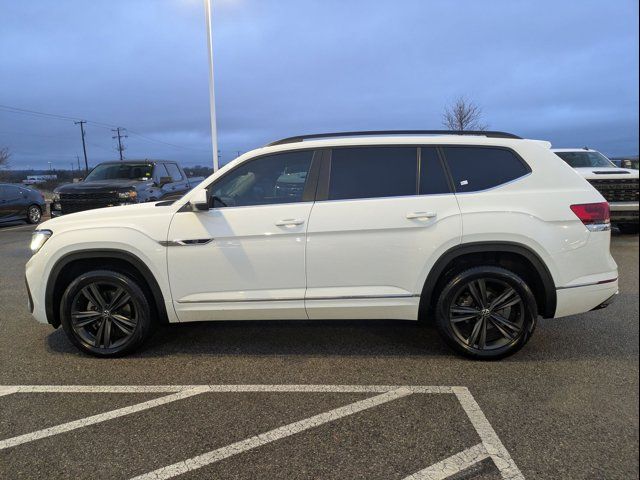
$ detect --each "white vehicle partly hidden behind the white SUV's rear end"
[553,148,638,233]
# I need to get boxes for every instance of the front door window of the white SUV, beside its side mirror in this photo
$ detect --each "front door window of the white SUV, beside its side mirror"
[210,151,313,207]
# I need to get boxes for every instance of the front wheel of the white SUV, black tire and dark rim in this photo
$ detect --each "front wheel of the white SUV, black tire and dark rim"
[60,270,153,357]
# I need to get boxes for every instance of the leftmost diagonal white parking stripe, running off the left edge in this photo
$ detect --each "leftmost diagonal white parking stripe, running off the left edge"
[0,388,207,450]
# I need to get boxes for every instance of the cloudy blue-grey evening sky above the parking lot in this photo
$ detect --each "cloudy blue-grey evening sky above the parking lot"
[0,0,638,168]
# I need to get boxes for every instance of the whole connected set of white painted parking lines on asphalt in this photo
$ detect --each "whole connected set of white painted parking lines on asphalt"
[0,385,524,480]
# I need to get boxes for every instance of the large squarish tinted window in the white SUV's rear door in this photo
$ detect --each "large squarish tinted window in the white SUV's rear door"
[328,147,418,200]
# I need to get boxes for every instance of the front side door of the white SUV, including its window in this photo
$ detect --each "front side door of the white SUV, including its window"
[167,150,320,321]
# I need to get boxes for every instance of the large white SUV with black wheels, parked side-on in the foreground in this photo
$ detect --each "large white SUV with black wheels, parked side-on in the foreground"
[26,131,618,358]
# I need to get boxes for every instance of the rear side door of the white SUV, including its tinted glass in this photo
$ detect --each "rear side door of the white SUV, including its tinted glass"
[305,146,462,320]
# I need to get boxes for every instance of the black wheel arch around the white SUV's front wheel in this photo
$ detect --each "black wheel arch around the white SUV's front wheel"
[45,249,168,328]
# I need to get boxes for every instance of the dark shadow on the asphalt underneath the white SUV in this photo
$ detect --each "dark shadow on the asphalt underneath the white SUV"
[47,320,453,358]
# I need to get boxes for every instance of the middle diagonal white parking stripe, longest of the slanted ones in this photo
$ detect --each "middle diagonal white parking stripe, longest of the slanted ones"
[134,388,412,480]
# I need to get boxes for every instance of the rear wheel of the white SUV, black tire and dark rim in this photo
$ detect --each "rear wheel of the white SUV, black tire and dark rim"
[435,266,538,360]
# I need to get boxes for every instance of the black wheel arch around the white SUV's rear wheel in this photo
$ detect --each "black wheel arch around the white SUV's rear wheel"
[419,242,557,318]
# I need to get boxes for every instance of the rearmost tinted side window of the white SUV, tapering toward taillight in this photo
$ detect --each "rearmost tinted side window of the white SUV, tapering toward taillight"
[444,147,529,192]
